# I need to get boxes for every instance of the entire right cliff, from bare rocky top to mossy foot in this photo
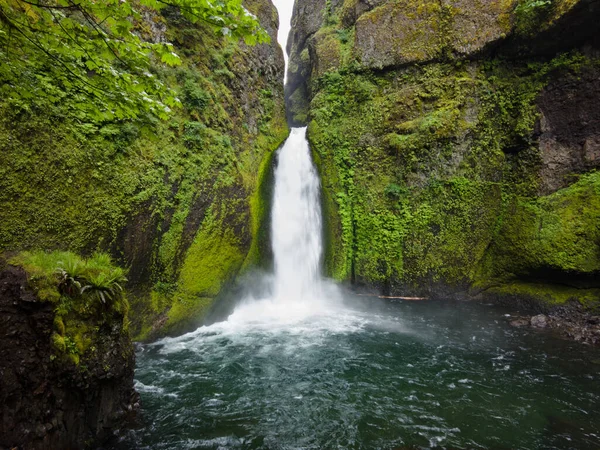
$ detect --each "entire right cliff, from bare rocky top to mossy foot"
[286,0,600,308]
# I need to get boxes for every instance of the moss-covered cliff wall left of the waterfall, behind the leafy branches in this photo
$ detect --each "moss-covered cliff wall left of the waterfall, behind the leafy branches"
[0,0,288,340]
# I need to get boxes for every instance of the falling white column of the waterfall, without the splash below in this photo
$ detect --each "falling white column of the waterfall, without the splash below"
[271,128,323,303]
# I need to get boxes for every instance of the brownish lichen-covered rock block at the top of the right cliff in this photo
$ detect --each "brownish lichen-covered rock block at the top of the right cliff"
[354,0,515,69]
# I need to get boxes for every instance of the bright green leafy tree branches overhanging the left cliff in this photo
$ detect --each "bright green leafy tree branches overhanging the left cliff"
[0,0,269,122]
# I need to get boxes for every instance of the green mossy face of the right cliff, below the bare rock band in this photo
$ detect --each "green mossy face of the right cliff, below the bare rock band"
[309,49,600,298]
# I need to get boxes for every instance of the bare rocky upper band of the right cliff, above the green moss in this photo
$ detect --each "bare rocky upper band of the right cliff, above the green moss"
[286,0,600,124]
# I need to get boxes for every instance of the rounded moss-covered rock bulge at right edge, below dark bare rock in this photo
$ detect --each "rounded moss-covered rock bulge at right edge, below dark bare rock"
[489,172,600,276]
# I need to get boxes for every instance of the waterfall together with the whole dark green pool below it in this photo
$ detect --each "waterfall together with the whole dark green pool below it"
[116,129,600,449]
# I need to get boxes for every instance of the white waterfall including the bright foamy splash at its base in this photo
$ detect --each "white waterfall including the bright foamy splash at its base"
[228,127,341,327]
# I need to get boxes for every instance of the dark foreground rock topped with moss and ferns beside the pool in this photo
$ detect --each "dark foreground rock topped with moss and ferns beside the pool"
[0,252,139,449]
